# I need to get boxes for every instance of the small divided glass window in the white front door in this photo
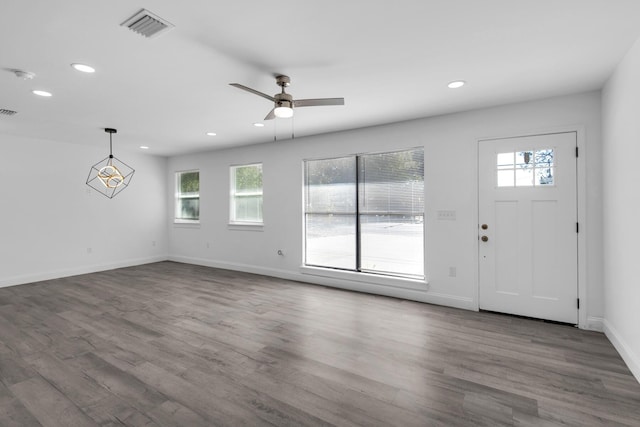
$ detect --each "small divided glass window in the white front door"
[496,148,555,187]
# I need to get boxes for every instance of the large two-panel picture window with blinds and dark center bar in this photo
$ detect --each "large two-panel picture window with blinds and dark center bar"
[304,149,424,278]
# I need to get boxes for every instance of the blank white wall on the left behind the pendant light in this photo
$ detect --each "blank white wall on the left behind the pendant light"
[0,135,168,286]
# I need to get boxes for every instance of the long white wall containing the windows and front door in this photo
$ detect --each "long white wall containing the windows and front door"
[167,92,603,329]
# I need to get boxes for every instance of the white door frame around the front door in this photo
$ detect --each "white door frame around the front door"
[474,125,584,329]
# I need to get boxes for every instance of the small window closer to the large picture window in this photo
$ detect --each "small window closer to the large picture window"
[230,163,263,225]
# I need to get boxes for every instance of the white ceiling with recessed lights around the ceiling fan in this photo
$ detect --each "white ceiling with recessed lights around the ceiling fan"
[0,0,640,155]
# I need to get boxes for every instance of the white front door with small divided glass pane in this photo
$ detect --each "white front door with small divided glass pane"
[478,132,578,324]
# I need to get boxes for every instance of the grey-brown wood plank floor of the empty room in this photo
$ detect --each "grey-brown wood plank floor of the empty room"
[0,262,640,426]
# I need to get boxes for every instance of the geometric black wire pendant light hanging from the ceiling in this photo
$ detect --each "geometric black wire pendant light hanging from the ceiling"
[87,128,135,199]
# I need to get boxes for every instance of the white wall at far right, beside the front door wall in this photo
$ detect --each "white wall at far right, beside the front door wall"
[602,40,640,380]
